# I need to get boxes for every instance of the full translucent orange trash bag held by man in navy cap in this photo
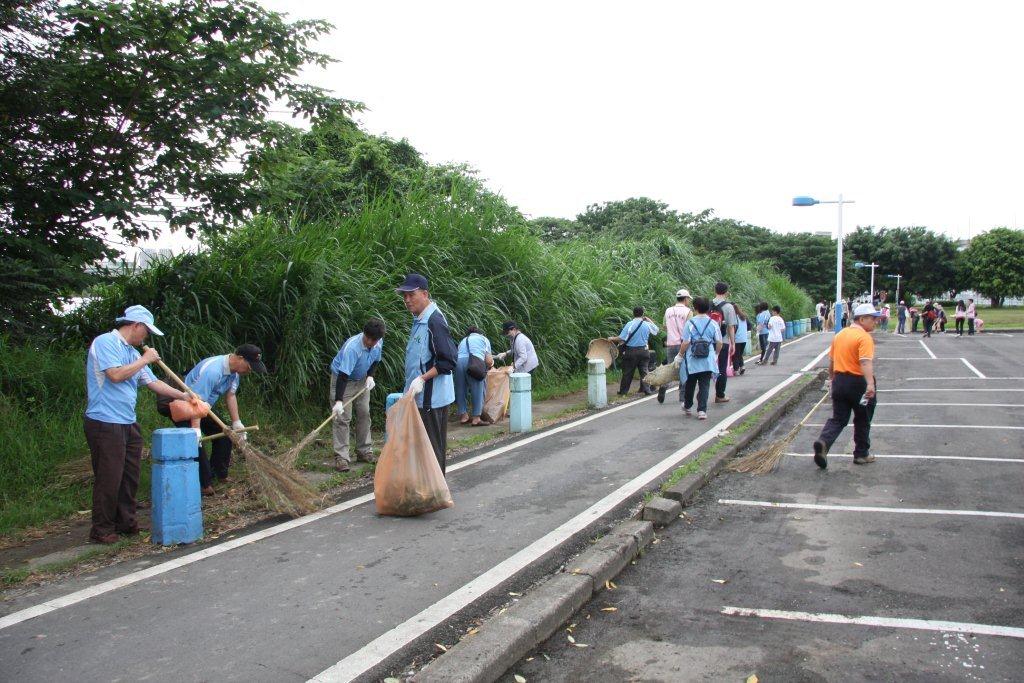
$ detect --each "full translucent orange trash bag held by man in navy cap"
[374,393,455,517]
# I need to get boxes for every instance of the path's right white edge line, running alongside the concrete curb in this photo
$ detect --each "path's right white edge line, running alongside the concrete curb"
[309,349,828,683]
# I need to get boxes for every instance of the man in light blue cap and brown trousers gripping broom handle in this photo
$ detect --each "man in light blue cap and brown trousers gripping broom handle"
[84,306,188,544]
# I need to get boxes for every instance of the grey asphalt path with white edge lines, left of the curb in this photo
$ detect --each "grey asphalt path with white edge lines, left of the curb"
[0,335,827,681]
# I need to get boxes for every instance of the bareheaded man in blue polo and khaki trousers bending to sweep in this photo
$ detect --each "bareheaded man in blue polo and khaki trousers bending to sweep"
[331,318,384,472]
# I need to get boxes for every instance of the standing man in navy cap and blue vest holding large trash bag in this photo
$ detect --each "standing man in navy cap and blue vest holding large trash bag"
[395,272,459,473]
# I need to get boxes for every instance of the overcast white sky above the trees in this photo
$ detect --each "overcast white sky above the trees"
[138,0,1024,253]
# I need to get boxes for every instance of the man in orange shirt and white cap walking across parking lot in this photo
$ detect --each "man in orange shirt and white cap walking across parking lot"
[814,303,882,469]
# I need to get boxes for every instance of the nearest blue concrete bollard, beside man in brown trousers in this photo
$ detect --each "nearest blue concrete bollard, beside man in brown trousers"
[152,427,203,546]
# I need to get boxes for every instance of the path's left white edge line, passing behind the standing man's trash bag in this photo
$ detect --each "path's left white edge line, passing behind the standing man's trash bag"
[0,342,828,631]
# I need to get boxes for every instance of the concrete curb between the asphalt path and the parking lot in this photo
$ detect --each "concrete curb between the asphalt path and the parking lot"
[410,374,823,683]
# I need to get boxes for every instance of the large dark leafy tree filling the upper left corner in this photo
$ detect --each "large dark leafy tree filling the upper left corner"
[0,0,357,329]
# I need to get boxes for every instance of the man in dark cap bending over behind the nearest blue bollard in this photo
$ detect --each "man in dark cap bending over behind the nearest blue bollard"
[157,344,266,496]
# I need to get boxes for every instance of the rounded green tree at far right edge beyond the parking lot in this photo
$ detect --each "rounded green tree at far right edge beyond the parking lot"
[959,227,1024,307]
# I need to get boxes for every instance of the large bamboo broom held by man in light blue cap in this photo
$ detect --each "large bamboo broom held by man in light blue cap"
[143,347,319,517]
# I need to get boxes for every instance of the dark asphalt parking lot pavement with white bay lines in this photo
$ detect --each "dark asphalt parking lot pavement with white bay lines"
[505,336,1024,681]
